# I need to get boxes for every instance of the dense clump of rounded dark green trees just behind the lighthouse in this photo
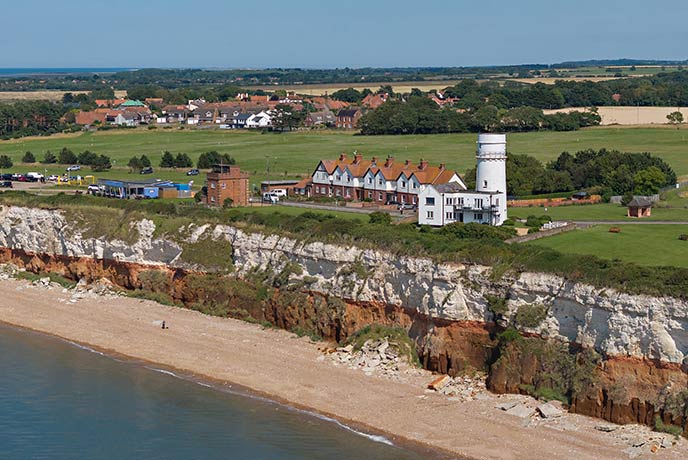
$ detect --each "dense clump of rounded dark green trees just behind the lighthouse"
[466,149,676,197]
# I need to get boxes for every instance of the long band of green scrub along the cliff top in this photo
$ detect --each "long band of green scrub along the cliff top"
[0,192,688,298]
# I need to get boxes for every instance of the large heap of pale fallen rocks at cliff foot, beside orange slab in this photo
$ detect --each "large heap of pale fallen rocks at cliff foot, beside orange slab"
[327,337,425,379]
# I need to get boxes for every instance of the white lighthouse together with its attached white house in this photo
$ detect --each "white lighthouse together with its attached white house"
[418,134,507,226]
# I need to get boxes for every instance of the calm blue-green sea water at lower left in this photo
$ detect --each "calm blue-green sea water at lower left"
[0,325,424,460]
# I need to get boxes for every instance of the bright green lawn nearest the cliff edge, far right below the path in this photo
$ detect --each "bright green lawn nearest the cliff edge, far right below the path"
[527,225,688,267]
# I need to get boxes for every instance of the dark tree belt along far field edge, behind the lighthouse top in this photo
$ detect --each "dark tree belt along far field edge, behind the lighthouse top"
[359,96,601,135]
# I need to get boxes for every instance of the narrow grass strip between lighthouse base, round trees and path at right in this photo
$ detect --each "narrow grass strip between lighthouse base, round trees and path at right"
[508,199,688,222]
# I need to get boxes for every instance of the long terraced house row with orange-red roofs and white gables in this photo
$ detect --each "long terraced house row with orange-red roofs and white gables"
[311,153,466,205]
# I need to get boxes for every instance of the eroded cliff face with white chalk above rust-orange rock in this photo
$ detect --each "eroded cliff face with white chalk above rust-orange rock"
[0,206,688,432]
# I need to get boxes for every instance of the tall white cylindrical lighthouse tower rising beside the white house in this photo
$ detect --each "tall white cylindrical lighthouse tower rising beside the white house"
[475,134,507,225]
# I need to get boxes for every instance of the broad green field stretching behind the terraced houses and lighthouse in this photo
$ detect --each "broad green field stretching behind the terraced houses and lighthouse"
[0,127,688,183]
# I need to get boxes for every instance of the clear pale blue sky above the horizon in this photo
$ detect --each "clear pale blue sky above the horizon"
[5,0,688,68]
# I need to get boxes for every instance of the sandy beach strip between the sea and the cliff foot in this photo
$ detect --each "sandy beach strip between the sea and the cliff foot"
[0,280,688,460]
